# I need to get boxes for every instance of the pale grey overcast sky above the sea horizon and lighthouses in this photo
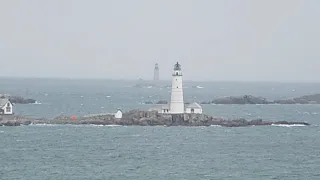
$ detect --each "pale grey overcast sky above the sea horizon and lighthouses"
[0,0,320,82]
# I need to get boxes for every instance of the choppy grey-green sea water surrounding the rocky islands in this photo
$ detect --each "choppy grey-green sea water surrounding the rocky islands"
[0,79,320,180]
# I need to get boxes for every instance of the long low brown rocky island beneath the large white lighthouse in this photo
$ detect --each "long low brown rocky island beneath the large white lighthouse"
[0,110,309,127]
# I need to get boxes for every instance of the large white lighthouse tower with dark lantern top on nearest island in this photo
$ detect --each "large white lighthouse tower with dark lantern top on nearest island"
[170,62,184,114]
